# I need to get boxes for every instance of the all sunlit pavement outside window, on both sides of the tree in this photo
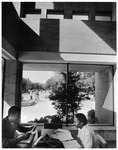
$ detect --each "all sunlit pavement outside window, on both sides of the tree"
[21,92,95,123]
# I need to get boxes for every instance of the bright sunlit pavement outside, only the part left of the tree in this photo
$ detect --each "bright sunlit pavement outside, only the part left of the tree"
[21,93,56,123]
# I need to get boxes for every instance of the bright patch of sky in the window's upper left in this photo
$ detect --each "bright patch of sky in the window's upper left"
[23,71,54,83]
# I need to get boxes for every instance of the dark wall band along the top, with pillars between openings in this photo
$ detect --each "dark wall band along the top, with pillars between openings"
[21,2,112,20]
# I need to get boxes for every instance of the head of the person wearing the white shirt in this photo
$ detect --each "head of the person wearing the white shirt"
[74,113,87,129]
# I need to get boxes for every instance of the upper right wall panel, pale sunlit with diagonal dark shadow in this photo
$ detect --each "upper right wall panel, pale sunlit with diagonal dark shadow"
[59,20,116,54]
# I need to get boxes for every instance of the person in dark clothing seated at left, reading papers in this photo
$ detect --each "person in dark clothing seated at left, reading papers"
[2,106,31,148]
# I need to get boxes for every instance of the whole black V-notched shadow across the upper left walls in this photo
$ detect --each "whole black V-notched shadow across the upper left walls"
[2,2,59,52]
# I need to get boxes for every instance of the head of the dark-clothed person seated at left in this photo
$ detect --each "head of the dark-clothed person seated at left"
[8,106,21,123]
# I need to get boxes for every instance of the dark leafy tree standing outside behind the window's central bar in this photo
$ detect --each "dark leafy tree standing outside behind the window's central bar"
[49,71,80,121]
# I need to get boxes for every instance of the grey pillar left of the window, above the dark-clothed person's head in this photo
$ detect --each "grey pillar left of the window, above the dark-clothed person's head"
[3,60,22,106]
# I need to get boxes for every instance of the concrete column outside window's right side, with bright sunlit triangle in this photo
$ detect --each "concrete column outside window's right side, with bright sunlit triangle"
[95,67,114,125]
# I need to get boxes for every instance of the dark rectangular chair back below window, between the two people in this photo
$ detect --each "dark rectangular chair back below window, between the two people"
[44,123,62,129]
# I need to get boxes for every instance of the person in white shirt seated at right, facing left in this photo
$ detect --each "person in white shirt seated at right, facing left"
[74,113,99,148]
